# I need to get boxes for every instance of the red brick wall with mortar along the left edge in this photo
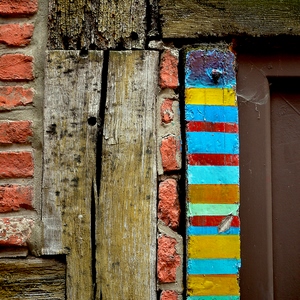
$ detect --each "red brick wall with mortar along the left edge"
[0,0,38,246]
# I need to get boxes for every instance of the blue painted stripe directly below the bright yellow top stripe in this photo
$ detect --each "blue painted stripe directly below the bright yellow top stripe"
[185,104,238,123]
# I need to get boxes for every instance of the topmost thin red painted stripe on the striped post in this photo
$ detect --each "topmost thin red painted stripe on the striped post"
[186,122,239,133]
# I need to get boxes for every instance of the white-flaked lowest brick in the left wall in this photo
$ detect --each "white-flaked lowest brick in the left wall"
[0,217,34,246]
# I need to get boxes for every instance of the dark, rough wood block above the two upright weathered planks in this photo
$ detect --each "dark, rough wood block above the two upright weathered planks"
[49,0,147,50]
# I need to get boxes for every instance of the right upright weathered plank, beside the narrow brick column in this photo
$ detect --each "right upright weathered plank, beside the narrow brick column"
[96,51,159,300]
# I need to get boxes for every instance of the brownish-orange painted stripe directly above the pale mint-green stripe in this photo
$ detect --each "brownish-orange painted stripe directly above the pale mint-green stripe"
[188,184,240,204]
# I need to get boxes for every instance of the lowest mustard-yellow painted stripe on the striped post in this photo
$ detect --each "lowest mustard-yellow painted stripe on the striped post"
[187,275,239,296]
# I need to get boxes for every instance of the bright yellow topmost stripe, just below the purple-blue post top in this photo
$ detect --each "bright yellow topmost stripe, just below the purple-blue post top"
[185,88,237,106]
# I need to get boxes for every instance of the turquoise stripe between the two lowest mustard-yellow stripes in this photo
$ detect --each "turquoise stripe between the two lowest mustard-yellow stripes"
[187,258,241,275]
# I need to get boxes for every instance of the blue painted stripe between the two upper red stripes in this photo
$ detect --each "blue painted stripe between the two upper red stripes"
[186,132,239,154]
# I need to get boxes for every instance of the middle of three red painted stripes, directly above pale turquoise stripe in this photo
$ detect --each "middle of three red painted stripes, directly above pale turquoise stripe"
[187,153,239,166]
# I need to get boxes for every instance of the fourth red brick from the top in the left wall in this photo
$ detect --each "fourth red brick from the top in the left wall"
[0,86,33,111]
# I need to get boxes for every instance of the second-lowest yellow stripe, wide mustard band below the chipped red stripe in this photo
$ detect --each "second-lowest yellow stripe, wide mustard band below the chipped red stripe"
[188,235,240,259]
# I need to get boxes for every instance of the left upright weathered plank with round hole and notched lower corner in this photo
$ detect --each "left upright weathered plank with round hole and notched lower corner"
[42,51,103,299]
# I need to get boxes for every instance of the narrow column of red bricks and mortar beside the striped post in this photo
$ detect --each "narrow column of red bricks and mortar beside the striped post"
[157,48,183,300]
